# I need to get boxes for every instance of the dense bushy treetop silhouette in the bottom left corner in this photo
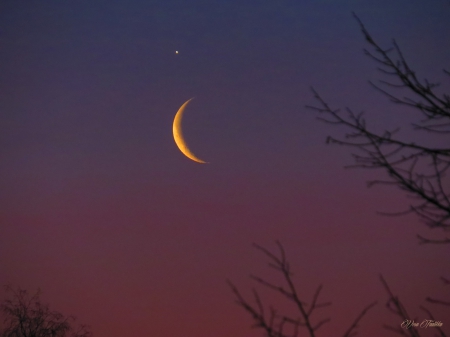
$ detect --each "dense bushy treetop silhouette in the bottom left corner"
[0,286,92,337]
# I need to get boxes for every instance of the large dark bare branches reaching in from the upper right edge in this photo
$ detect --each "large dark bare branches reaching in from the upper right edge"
[307,14,450,243]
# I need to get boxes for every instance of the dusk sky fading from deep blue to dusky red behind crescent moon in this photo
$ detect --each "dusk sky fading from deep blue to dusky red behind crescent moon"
[0,0,450,337]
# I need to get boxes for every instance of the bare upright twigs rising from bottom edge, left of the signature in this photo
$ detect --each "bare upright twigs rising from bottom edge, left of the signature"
[228,241,376,337]
